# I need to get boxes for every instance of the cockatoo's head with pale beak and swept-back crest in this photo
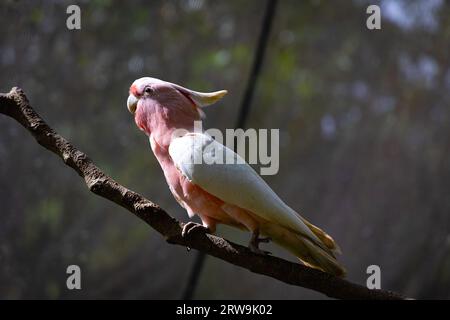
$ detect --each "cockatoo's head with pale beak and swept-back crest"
[127,77,227,116]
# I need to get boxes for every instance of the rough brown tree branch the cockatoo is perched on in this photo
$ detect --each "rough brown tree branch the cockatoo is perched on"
[0,87,404,299]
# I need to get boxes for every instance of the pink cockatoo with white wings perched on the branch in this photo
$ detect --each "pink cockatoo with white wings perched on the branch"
[127,77,345,276]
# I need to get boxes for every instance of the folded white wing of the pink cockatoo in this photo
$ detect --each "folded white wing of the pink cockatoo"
[169,133,321,244]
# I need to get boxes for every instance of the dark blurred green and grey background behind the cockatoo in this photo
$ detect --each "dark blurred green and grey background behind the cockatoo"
[0,0,450,299]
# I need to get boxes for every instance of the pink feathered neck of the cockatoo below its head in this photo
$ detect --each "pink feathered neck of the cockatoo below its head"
[135,104,200,151]
